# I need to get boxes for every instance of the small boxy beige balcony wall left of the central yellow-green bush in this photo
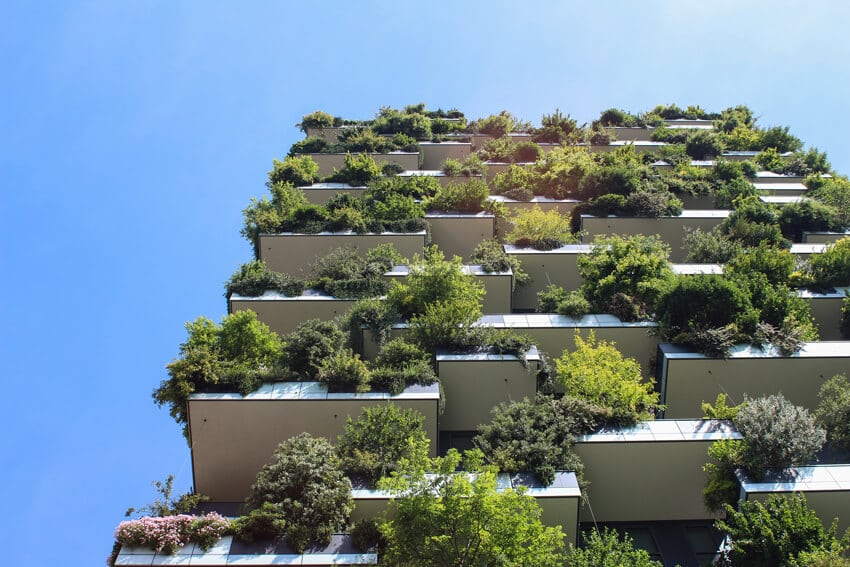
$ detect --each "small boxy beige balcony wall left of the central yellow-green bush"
[437,353,539,431]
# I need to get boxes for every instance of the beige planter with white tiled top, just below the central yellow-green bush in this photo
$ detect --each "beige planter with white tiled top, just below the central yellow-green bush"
[574,420,741,522]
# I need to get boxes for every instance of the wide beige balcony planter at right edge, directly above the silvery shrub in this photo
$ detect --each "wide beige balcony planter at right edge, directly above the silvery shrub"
[657,341,850,419]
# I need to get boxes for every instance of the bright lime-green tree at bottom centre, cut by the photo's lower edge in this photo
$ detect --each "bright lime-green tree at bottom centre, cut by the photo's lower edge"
[381,451,564,567]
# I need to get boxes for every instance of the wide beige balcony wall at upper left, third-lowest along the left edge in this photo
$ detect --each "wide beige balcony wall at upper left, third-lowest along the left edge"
[259,231,425,277]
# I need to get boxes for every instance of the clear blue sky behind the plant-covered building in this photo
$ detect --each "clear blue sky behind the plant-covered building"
[0,0,850,566]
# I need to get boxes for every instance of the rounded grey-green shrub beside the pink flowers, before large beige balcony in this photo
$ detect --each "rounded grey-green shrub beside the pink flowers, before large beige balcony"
[246,433,352,553]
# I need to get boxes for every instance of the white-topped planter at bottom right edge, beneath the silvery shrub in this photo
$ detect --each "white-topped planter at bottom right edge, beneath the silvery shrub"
[738,464,850,535]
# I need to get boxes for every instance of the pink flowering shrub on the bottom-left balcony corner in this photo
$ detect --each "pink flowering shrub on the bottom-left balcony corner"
[115,512,230,554]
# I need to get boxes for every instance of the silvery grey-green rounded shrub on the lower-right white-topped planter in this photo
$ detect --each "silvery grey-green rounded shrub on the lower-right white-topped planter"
[735,394,826,480]
